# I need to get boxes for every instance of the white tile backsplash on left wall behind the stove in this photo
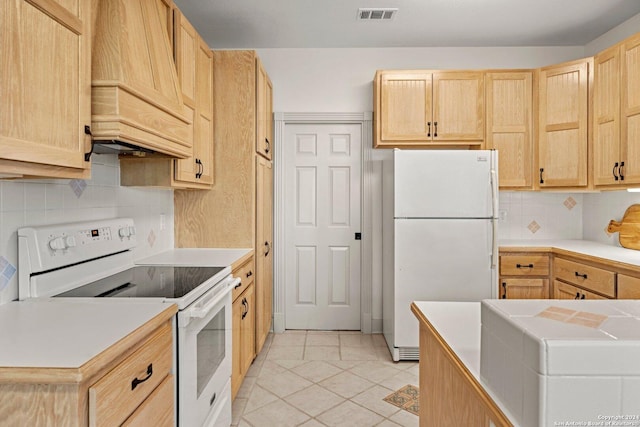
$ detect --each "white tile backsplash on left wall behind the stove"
[0,154,173,304]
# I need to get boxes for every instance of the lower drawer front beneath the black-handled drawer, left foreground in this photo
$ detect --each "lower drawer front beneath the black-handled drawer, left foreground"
[123,375,175,427]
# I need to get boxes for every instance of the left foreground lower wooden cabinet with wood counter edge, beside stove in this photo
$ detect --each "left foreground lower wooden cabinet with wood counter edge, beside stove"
[0,307,176,427]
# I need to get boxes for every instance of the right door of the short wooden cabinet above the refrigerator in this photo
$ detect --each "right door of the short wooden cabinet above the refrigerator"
[427,71,484,142]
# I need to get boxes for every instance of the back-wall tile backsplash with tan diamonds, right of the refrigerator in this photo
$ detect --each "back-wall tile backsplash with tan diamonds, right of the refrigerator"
[499,191,586,240]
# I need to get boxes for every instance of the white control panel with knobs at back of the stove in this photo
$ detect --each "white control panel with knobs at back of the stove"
[18,218,136,273]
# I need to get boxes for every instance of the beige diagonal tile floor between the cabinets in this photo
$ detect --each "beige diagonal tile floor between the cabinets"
[232,331,418,427]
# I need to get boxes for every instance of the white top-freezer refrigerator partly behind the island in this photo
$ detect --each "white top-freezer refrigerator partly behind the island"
[382,149,498,361]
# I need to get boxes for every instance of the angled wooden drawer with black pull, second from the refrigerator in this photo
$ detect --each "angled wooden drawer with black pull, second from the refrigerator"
[553,258,616,298]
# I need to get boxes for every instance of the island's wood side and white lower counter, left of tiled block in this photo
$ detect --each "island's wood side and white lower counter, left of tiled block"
[411,301,515,427]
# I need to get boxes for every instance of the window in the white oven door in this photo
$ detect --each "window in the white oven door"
[196,307,226,398]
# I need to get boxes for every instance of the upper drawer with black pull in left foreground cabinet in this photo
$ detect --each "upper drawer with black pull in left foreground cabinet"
[89,323,173,426]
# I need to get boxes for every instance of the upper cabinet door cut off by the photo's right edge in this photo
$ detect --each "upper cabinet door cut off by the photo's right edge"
[620,35,640,184]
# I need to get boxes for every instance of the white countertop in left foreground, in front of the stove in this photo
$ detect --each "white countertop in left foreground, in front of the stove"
[0,298,170,368]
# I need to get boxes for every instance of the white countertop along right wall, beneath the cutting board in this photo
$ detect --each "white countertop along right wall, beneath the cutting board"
[499,240,640,267]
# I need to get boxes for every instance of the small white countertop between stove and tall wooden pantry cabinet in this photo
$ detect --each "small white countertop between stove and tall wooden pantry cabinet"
[135,248,252,267]
